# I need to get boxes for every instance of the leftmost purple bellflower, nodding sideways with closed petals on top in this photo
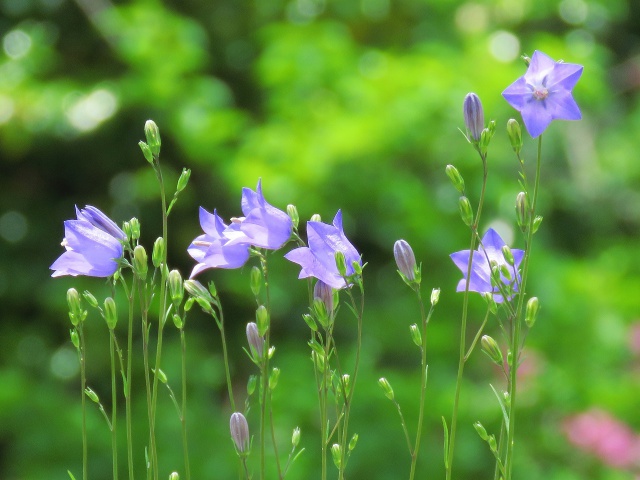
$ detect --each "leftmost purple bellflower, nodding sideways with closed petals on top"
[50,206,127,277]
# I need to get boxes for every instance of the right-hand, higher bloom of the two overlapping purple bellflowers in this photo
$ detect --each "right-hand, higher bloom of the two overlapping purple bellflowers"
[224,180,293,250]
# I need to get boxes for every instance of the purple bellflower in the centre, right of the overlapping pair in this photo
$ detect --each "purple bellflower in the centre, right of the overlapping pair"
[284,210,362,289]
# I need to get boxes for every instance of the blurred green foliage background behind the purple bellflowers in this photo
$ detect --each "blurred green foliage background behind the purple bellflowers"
[0,0,640,480]
